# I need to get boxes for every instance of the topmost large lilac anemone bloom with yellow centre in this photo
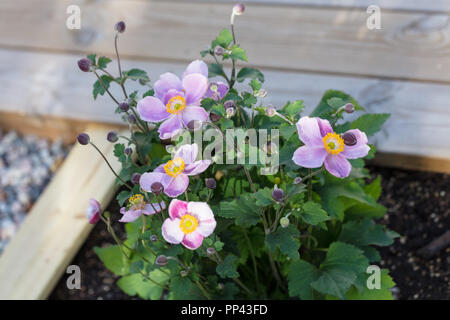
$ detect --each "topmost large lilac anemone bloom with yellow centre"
[137,60,208,139]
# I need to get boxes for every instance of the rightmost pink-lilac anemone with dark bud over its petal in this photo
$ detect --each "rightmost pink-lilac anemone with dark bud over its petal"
[292,117,370,178]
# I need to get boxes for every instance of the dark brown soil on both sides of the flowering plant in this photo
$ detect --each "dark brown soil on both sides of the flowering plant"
[49,167,450,299]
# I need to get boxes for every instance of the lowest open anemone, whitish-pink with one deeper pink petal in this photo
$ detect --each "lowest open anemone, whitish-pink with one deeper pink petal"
[161,199,216,250]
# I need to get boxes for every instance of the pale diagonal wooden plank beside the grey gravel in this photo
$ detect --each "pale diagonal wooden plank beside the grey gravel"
[0,126,120,300]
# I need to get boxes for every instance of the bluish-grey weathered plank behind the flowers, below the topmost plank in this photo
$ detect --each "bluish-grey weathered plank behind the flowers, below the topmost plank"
[0,51,450,166]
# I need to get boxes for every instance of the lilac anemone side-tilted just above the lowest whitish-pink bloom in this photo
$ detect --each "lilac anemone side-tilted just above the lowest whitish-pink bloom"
[139,143,211,198]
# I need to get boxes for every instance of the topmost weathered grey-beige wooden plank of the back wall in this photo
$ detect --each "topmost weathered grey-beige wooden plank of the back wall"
[0,0,450,82]
